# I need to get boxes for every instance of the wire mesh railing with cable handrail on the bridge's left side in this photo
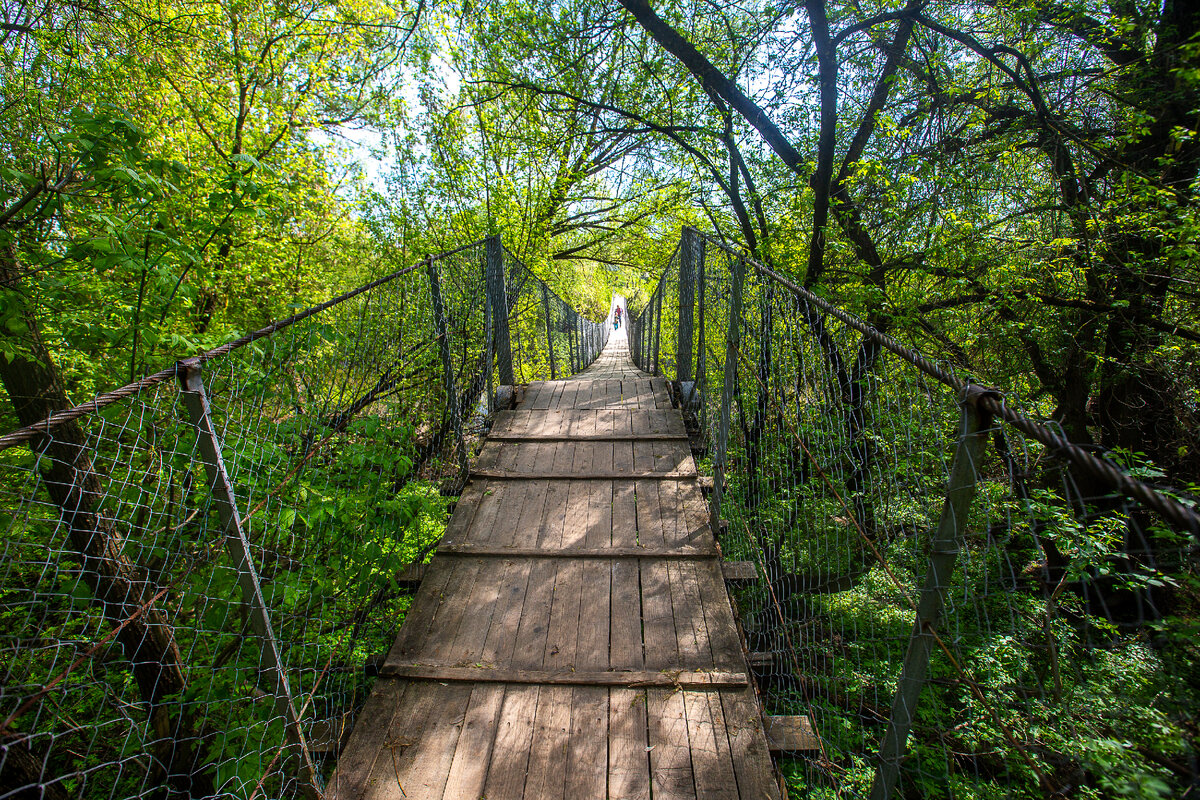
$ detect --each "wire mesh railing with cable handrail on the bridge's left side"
[0,237,599,799]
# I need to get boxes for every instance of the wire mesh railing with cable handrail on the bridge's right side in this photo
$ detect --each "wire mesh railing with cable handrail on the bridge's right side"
[630,229,1200,798]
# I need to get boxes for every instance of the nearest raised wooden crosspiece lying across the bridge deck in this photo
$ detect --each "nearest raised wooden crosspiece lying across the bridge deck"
[379,662,750,688]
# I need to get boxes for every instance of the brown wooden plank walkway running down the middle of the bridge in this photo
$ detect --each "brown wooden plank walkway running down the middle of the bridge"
[326,329,780,800]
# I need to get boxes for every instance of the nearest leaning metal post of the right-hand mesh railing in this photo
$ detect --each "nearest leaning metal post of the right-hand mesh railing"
[871,393,991,800]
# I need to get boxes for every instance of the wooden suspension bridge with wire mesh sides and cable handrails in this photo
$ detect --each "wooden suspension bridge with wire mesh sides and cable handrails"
[0,229,1200,800]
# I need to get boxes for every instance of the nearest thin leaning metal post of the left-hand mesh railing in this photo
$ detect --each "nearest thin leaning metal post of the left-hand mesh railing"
[179,359,320,796]
